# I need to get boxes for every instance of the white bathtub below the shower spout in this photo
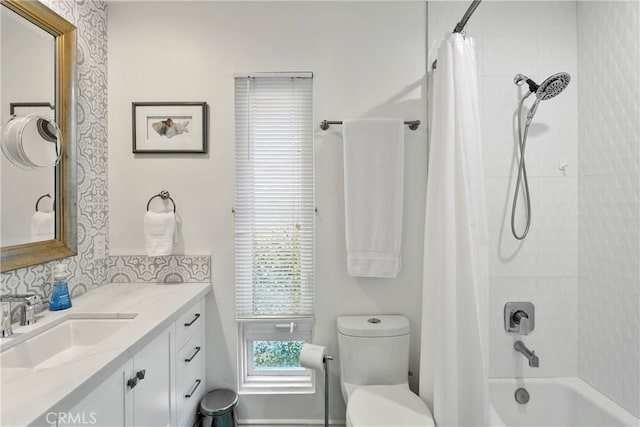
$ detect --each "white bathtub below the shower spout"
[489,378,640,427]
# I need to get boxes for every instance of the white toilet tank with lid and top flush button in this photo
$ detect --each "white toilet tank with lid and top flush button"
[338,316,409,390]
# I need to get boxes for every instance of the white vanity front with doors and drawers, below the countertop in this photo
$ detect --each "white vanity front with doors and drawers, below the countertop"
[58,299,206,427]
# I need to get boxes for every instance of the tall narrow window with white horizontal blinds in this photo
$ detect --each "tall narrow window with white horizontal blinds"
[235,74,314,393]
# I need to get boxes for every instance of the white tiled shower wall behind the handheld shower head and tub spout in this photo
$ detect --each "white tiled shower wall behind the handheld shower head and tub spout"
[428,1,578,377]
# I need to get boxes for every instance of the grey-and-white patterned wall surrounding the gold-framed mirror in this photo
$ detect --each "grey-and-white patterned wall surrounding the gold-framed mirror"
[0,0,109,298]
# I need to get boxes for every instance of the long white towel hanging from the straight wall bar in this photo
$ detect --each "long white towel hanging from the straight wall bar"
[342,119,404,278]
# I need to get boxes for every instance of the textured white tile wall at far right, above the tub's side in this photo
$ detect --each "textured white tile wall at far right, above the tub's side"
[578,1,640,416]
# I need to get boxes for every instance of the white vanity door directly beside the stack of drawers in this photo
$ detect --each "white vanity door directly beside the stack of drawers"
[133,329,171,427]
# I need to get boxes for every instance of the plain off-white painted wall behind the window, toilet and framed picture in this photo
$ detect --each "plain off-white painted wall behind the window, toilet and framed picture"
[109,2,427,420]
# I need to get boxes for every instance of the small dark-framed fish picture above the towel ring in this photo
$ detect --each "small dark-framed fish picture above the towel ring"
[131,102,208,154]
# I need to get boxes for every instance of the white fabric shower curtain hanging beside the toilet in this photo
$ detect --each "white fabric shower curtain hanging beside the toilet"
[420,33,491,426]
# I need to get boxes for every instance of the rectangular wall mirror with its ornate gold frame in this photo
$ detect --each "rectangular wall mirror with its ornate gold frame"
[0,0,77,271]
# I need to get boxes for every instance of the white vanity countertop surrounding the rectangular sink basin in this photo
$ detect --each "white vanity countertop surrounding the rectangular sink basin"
[0,283,212,427]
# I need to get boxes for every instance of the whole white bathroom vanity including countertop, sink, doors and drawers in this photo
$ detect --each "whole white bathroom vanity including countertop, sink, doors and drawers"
[0,282,212,427]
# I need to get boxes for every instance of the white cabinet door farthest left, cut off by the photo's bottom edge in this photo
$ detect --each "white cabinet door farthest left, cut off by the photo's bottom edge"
[69,361,131,427]
